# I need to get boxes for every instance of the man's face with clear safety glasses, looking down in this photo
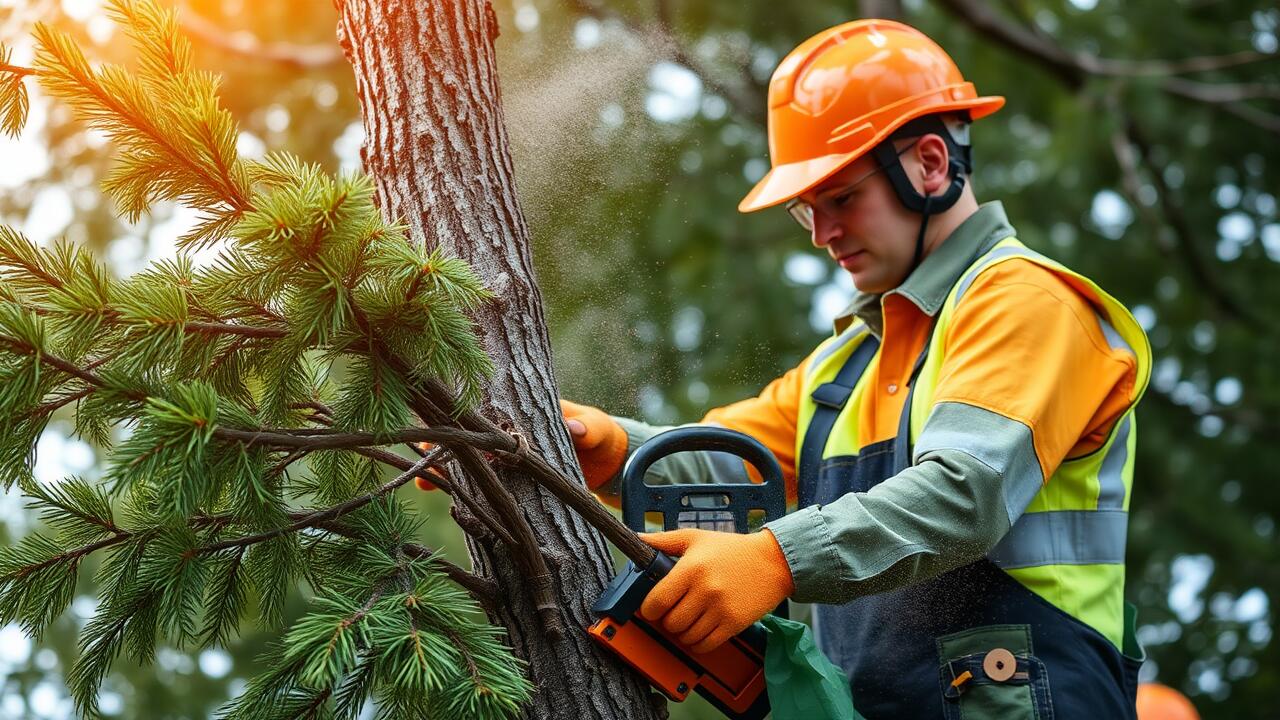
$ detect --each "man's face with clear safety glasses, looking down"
[800,151,920,293]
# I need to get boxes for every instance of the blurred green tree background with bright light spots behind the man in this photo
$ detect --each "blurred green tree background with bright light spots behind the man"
[0,0,1280,717]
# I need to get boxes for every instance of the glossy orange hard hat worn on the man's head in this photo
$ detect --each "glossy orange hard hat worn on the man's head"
[737,20,1005,213]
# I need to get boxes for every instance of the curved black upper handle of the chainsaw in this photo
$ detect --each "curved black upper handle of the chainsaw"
[622,425,787,533]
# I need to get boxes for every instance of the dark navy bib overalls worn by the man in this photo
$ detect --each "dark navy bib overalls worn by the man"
[799,337,1142,720]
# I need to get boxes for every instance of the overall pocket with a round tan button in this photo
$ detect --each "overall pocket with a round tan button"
[938,625,1053,720]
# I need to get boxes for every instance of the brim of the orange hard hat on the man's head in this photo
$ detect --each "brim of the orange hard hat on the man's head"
[737,95,1005,213]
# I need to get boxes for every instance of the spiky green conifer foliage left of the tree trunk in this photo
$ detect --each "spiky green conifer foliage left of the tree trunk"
[0,0,531,720]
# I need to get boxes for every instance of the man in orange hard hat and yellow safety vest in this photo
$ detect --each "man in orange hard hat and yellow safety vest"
[563,19,1151,719]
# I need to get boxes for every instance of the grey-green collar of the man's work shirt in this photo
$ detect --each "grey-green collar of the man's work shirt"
[835,200,1015,337]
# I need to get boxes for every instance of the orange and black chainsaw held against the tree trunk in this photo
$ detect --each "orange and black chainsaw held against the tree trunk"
[588,425,787,720]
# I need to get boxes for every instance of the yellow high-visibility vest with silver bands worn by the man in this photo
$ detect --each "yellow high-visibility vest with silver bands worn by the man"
[796,237,1151,647]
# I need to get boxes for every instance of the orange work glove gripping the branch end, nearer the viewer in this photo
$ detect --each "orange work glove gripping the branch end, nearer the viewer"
[640,528,795,652]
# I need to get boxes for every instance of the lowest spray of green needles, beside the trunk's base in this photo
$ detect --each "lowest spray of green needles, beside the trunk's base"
[220,548,531,720]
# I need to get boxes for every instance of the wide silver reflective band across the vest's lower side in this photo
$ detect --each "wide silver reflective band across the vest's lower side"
[987,510,1129,570]
